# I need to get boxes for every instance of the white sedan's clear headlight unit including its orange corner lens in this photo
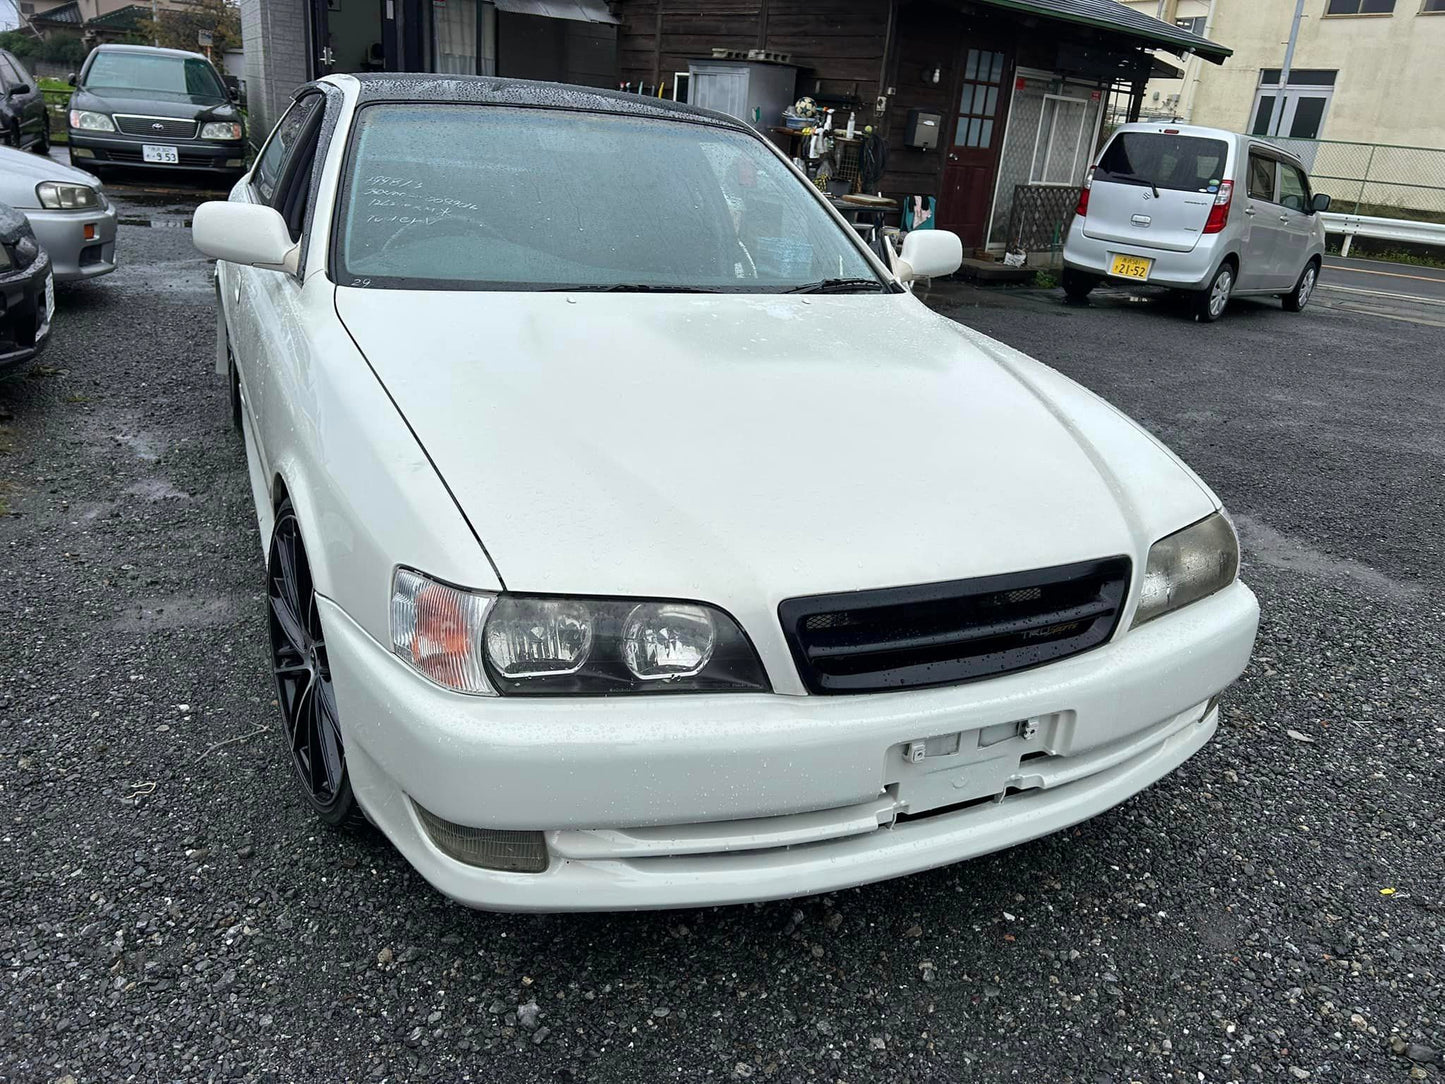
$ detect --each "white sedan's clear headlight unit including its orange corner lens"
[392,568,772,697]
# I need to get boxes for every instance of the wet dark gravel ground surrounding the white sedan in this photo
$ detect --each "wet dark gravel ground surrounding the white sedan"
[0,199,1445,1084]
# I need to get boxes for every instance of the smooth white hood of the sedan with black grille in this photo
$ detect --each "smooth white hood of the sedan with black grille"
[337,288,1215,607]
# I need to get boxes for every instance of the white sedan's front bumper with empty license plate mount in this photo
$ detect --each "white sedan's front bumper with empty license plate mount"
[322,584,1259,911]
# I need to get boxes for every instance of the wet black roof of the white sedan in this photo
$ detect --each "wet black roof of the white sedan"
[322,72,754,133]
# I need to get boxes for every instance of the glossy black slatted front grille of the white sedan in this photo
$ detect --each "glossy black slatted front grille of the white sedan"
[777,556,1130,692]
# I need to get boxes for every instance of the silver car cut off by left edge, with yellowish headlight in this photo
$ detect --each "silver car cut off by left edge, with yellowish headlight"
[0,147,116,282]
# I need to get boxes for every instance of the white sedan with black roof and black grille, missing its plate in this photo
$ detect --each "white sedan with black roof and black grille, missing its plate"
[194,75,1259,911]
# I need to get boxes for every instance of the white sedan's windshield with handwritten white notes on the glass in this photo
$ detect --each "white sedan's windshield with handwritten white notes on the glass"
[337,104,886,293]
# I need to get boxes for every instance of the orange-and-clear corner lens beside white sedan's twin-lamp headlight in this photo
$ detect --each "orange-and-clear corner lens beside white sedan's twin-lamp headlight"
[392,568,496,695]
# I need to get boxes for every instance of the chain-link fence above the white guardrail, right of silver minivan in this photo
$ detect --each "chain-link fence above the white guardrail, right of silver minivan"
[1270,137,1445,223]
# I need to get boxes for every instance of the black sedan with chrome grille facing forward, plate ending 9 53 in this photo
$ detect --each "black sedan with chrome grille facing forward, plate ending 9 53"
[69,45,246,176]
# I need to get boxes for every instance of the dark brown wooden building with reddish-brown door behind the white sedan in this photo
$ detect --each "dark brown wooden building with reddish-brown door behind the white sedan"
[611,0,1230,251]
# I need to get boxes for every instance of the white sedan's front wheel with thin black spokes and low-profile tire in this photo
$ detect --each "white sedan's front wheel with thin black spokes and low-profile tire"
[266,497,364,827]
